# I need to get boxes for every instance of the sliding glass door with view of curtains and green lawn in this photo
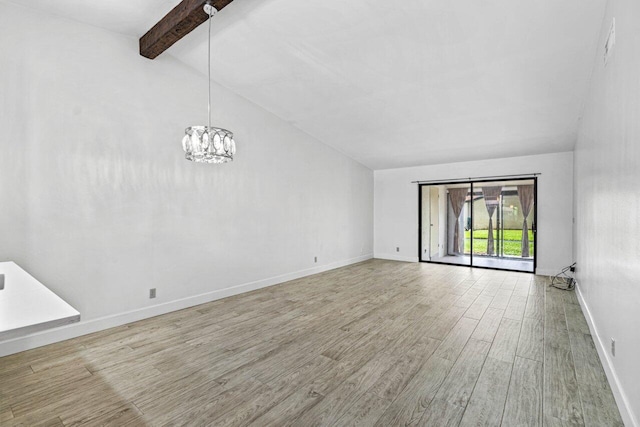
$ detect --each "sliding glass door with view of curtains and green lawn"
[420,178,537,272]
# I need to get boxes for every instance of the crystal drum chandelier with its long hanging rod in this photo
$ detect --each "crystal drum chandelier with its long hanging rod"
[182,3,236,164]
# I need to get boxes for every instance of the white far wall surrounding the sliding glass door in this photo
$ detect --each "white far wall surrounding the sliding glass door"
[374,153,573,274]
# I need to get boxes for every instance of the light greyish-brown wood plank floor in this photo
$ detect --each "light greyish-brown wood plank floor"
[0,260,622,426]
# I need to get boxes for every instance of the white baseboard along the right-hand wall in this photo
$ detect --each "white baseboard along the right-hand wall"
[576,284,640,427]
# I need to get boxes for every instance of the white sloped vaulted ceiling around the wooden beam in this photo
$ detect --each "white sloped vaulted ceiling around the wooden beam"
[6,0,606,169]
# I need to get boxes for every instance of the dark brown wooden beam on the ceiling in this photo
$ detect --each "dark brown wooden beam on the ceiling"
[140,0,233,59]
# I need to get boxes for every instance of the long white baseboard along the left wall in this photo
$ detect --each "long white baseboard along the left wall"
[0,254,373,357]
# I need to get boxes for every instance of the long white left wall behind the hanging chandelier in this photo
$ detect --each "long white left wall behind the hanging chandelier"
[0,2,373,353]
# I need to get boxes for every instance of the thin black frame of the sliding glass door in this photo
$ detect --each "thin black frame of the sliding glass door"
[418,175,538,274]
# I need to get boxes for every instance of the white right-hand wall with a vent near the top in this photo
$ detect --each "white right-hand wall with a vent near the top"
[575,0,640,426]
